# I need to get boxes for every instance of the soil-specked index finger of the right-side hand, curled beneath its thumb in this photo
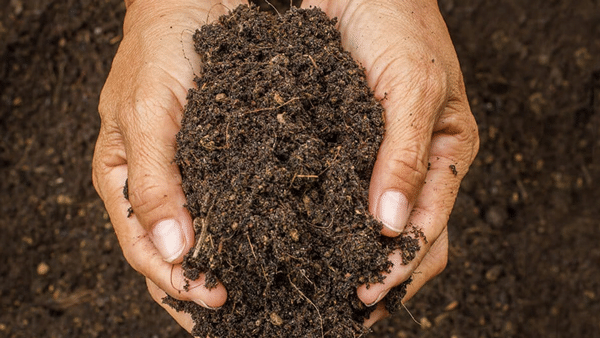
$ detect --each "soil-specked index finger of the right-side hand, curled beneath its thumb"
[359,104,478,304]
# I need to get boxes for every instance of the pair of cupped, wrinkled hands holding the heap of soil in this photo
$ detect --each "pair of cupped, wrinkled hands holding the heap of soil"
[93,0,479,331]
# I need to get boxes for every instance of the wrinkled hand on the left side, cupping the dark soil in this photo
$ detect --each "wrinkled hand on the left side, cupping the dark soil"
[93,0,242,330]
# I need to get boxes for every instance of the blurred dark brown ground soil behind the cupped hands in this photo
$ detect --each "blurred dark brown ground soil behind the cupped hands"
[0,0,600,337]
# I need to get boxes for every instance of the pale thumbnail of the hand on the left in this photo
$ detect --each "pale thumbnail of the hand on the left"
[152,219,185,263]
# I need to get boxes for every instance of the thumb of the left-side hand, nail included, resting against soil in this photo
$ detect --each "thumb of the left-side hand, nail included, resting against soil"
[121,85,194,263]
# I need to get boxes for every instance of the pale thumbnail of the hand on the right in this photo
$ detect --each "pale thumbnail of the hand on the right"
[377,190,408,232]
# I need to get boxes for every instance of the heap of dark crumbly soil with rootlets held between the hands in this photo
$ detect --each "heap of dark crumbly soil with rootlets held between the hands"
[165,6,420,338]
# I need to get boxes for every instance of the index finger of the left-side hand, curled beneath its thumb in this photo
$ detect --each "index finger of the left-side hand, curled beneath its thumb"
[97,154,227,308]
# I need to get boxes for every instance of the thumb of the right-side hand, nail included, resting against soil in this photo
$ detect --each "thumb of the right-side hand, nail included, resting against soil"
[369,67,446,236]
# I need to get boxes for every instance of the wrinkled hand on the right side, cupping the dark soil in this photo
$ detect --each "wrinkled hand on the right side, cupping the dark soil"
[302,0,479,326]
